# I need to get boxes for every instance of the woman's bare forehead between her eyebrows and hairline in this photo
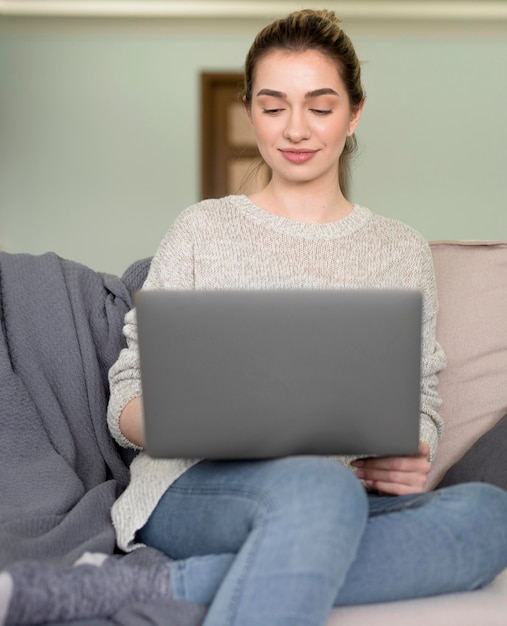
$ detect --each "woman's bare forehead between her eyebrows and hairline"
[253,50,344,95]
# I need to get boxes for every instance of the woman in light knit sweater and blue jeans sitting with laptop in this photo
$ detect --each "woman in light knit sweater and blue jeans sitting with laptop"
[104,10,507,626]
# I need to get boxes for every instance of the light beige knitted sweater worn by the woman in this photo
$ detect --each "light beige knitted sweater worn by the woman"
[108,196,445,550]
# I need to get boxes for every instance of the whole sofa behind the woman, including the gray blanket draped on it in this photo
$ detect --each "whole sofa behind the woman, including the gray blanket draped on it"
[0,241,507,626]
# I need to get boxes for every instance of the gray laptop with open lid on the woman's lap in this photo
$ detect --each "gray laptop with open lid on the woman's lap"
[136,289,421,459]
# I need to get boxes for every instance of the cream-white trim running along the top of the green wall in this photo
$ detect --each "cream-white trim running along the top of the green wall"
[0,0,507,21]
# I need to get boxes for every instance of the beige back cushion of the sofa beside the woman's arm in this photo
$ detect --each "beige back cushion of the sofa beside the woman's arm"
[428,242,507,488]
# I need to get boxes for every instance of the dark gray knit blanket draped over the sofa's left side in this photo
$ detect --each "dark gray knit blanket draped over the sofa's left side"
[0,253,188,626]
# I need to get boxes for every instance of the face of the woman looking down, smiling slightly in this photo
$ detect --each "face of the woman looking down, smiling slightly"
[248,50,361,188]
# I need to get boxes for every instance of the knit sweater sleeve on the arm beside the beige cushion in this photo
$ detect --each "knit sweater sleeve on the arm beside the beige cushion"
[420,239,446,460]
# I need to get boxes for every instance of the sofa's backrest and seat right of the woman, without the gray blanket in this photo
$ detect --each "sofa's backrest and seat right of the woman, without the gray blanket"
[327,241,507,626]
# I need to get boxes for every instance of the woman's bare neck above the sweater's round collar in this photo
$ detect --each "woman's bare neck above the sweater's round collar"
[250,180,353,224]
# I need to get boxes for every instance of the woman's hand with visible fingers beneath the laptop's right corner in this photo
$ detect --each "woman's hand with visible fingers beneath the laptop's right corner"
[352,441,431,496]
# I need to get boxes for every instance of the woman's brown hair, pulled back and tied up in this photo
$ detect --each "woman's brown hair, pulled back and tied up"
[242,9,365,195]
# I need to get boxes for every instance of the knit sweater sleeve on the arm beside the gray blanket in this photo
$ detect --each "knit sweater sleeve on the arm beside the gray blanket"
[107,213,194,448]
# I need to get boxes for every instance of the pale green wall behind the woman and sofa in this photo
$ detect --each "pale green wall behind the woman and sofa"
[0,17,507,272]
